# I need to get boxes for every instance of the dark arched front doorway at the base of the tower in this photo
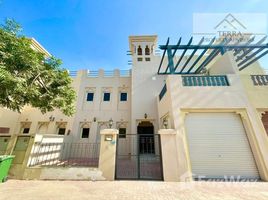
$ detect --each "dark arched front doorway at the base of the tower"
[137,121,155,154]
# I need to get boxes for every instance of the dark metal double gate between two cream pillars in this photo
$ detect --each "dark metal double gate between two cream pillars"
[115,134,163,180]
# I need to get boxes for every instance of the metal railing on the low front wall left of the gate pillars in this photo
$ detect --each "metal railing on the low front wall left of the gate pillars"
[29,143,100,167]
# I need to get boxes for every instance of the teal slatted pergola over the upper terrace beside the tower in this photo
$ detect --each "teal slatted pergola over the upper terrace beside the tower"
[158,37,268,74]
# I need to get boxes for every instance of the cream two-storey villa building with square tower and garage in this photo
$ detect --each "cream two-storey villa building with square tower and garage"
[0,36,268,181]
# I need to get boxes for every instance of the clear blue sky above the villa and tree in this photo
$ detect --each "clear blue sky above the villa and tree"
[0,0,268,70]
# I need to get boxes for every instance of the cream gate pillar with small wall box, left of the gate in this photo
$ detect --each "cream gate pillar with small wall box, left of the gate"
[99,129,118,181]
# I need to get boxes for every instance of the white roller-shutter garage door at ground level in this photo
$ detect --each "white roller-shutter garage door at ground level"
[186,113,259,178]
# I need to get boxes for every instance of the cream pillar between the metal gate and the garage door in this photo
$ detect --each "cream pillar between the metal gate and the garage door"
[158,129,180,181]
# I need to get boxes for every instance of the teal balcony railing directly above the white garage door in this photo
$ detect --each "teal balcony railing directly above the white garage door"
[182,75,229,87]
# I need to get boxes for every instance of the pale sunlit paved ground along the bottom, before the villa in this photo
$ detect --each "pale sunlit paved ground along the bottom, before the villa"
[0,180,268,200]
